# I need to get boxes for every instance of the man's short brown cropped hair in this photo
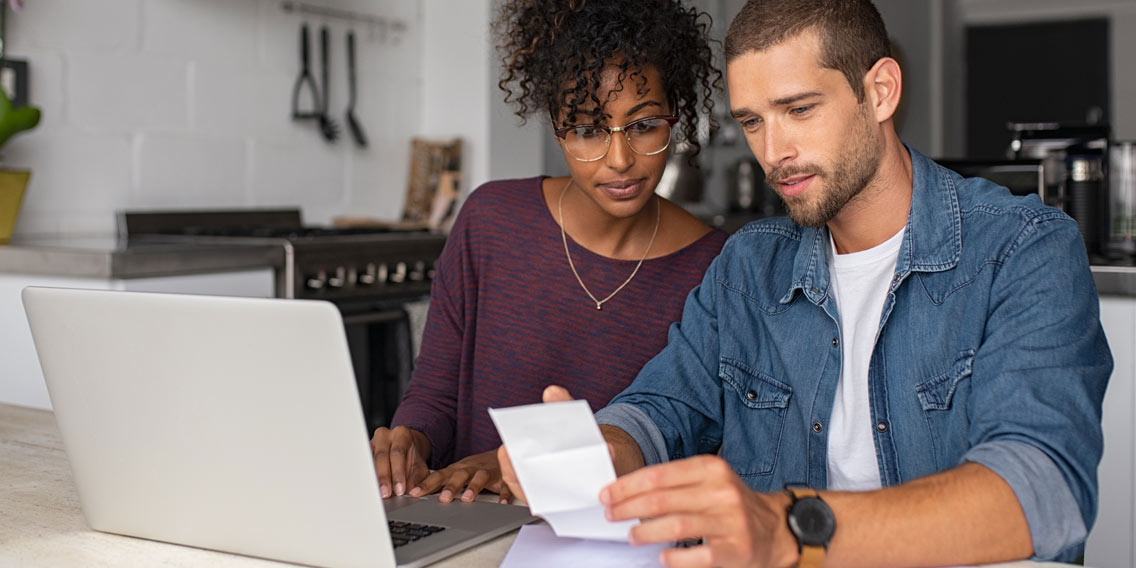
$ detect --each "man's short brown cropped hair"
[726,0,892,101]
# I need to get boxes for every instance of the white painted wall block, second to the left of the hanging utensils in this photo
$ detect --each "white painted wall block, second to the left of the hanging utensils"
[68,55,190,133]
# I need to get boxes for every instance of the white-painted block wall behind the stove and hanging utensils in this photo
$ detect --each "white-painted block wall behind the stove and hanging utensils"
[0,0,422,235]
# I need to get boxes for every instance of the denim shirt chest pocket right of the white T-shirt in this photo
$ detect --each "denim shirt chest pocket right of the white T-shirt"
[916,349,975,470]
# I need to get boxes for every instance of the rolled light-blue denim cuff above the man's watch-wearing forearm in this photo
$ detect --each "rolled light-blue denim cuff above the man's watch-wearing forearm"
[962,440,1088,561]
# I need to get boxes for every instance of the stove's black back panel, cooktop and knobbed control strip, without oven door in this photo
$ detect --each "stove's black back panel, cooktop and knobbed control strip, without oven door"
[119,209,445,302]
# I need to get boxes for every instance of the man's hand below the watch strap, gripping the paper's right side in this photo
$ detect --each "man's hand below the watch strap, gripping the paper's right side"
[600,456,797,567]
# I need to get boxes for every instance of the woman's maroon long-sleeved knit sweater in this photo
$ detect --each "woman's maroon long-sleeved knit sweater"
[392,177,727,468]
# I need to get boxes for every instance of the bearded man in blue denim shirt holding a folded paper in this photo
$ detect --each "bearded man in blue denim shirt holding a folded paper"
[500,0,1112,567]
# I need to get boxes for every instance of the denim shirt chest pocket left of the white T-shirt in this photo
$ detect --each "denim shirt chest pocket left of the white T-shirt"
[718,358,793,478]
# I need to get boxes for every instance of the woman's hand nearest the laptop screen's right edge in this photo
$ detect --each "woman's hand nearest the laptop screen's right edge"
[370,426,431,499]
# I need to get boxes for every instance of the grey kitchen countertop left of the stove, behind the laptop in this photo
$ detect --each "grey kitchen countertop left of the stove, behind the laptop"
[0,236,284,279]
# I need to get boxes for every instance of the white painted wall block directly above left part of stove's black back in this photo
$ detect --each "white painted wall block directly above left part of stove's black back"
[131,134,248,208]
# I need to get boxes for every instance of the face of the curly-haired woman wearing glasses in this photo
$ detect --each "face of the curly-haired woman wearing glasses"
[557,66,671,218]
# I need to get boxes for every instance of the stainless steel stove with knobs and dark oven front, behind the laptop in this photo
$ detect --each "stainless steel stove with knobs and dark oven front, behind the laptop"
[119,209,445,431]
